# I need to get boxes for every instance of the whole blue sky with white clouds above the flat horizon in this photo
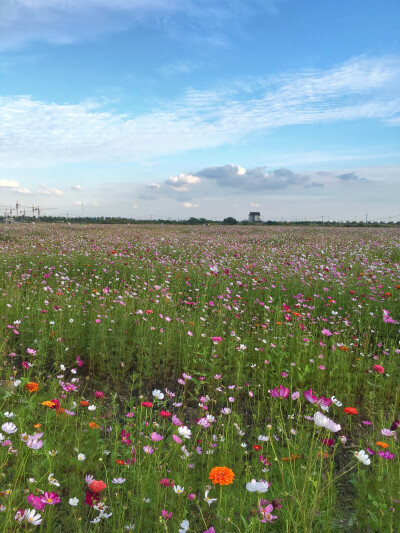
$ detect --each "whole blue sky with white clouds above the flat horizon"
[0,0,400,221]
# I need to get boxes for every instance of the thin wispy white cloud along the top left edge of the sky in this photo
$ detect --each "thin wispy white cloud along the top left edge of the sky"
[0,0,281,49]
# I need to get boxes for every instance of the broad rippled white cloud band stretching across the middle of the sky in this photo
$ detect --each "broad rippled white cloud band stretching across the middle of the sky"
[0,57,400,166]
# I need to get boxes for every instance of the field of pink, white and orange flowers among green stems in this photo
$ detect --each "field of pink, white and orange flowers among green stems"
[0,224,400,533]
